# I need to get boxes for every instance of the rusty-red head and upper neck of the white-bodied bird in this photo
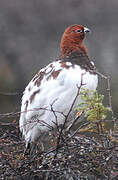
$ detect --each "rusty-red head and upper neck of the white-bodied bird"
[60,24,90,57]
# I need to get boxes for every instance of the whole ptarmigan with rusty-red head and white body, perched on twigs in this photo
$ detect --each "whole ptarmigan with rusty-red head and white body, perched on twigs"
[19,24,98,150]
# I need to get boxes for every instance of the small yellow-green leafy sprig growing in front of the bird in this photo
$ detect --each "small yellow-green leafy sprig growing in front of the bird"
[77,88,110,122]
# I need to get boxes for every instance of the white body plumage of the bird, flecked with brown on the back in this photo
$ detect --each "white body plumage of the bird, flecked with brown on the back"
[19,60,98,144]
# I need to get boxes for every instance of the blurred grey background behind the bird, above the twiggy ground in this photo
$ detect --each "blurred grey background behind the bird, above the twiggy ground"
[0,0,118,120]
